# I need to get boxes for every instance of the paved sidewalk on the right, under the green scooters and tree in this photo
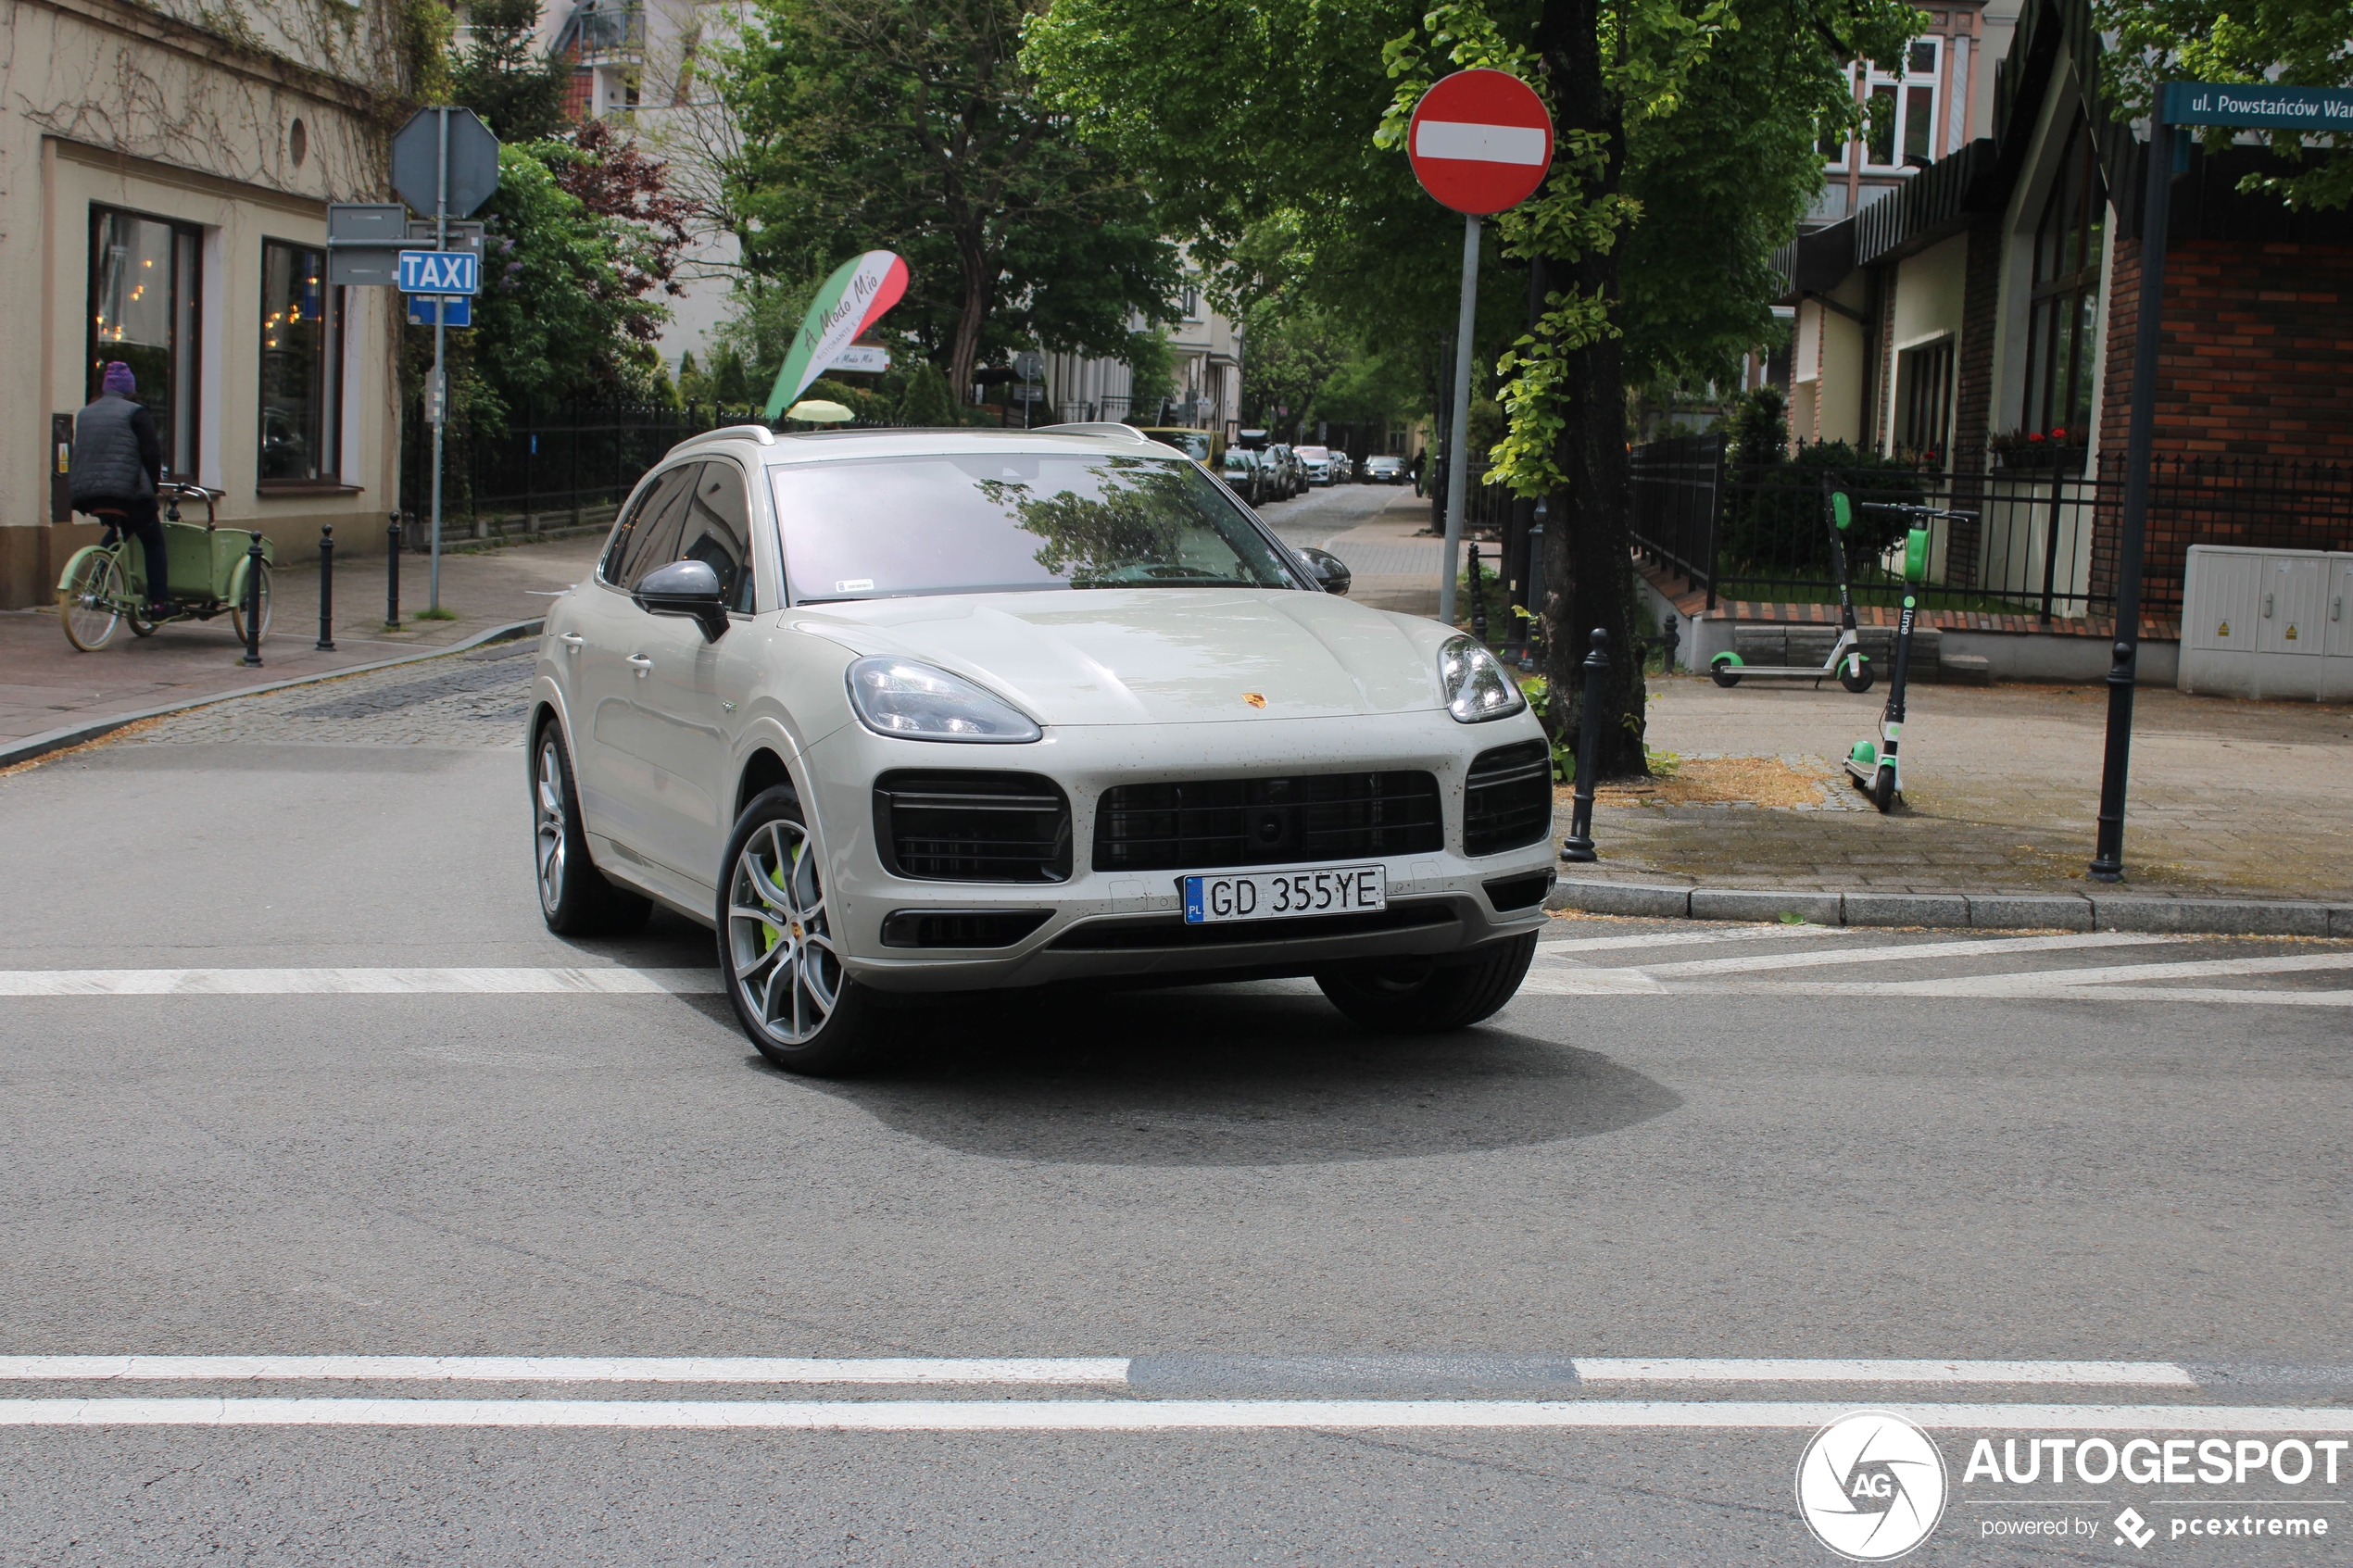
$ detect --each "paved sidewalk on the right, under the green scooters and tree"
[1560,674,2353,903]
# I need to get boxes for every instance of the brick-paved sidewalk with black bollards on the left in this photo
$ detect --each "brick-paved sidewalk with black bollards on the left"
[0,536,605,747]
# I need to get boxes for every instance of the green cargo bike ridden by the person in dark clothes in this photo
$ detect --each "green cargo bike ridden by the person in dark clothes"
[57,484,275,654]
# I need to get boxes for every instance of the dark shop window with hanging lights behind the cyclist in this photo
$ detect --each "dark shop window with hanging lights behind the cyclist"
[82,207,202,480]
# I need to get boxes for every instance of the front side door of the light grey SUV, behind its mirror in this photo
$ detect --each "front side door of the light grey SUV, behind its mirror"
[637,458,758,891]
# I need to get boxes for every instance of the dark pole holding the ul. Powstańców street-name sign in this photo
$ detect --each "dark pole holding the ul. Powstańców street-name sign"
[2090,113,2182,882]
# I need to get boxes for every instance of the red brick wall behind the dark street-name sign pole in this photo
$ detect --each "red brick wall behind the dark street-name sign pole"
[2099,240,2353,463]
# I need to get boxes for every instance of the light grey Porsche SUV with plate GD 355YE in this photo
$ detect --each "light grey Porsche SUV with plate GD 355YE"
[524,425,1555,1074]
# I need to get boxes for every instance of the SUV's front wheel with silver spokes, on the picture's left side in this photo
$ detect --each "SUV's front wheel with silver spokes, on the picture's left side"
[718,787,875,1077]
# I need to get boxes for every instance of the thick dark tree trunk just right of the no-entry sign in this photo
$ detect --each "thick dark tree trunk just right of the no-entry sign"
[1537,0,1650,778]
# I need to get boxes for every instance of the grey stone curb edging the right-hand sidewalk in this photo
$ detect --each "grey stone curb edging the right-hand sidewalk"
[1543,882,2353,938]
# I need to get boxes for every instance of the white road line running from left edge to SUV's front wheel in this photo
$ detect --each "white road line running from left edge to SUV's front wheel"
[0,969,723,997]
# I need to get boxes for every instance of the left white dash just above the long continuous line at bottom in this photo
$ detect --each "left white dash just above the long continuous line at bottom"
[0,1357,1127,1385]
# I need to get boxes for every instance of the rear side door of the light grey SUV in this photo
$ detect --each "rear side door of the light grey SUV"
[567,463,701,874]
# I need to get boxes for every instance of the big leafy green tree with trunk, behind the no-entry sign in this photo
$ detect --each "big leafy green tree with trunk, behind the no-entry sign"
[1026,0,1922,776]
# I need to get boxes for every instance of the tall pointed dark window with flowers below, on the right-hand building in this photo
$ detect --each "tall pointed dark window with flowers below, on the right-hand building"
[2023,119,2108,446]
